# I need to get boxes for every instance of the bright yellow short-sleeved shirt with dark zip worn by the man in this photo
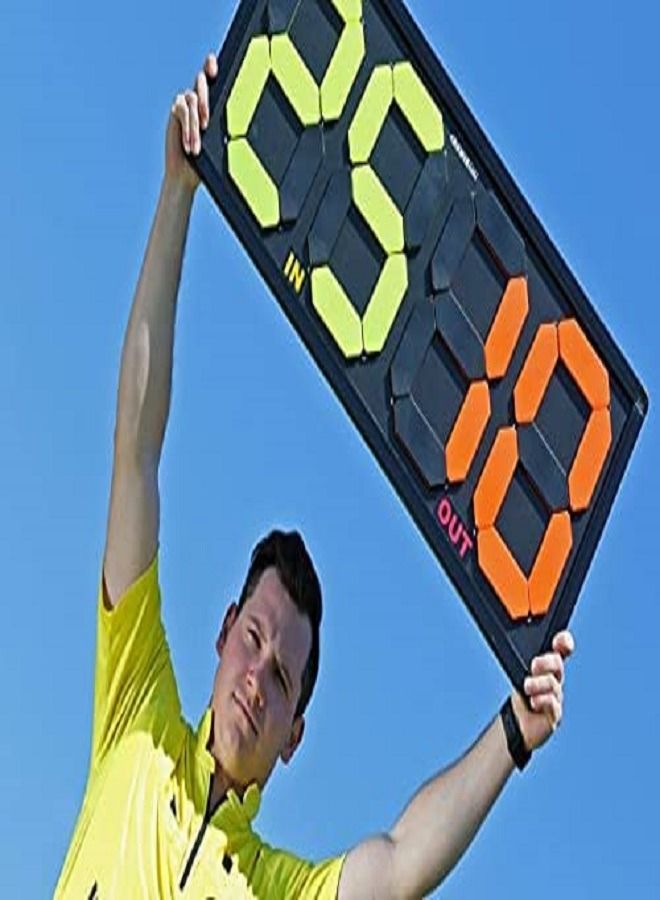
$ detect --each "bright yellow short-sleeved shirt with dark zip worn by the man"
[55,555,343,900]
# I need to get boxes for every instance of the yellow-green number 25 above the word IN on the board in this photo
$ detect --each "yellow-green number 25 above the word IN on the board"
[226,0,444,359]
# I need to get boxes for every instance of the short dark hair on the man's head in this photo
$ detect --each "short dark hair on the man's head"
[238,529,323,716]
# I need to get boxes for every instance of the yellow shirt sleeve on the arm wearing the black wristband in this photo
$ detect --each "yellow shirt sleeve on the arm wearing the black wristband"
[254,845,346,900]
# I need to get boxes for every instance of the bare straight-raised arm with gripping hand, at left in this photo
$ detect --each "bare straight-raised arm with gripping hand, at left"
[103,54,217,606]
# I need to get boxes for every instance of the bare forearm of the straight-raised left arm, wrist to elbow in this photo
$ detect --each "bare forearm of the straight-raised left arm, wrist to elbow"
[115,178,194,462]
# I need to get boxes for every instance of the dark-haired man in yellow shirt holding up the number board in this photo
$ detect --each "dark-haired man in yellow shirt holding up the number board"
[56,55,573,900]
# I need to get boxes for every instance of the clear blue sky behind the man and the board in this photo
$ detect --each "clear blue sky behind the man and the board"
[0,0,660,900]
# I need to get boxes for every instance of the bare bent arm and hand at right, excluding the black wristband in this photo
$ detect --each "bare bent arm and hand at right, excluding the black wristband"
[339,632,573,900]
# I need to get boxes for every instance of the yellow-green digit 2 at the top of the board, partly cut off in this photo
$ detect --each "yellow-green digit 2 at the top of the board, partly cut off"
[226,0,365,228]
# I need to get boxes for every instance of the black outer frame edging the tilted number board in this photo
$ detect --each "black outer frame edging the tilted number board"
[190,0,648,690]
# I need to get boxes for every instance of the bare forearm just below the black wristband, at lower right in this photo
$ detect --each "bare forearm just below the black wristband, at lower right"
[390,715,514,897]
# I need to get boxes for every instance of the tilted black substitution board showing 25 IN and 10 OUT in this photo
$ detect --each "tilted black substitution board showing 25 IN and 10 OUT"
[194,0,647,687]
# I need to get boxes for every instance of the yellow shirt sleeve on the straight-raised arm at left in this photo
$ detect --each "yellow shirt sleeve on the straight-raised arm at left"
[91,553,183,769]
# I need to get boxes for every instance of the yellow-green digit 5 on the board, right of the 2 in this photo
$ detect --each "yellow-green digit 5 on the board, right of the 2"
[311,62,444,359]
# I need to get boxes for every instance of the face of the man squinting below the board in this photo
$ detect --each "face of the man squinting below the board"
[212,568,312,787]
